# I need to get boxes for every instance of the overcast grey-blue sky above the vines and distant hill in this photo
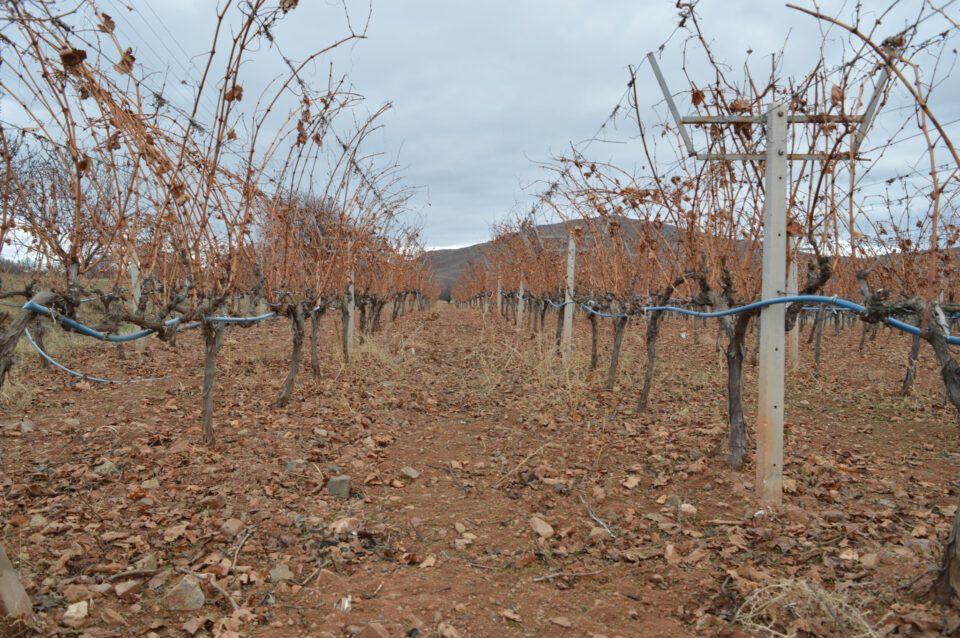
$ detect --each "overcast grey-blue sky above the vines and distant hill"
[7,0,958,252]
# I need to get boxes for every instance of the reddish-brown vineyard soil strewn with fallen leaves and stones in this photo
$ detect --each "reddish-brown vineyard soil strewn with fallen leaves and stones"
[0,304,960,638]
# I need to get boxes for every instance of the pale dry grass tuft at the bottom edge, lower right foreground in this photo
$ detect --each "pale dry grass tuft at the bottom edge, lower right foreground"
[734,579,882,638]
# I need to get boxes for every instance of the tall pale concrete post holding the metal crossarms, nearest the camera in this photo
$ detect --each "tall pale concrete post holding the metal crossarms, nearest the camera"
[757,104,787,503]
